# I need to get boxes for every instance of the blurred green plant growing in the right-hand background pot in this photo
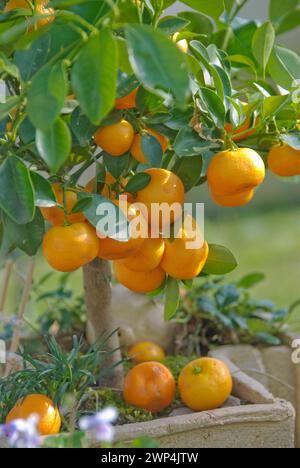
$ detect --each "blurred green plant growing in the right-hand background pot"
[175,273,300,354]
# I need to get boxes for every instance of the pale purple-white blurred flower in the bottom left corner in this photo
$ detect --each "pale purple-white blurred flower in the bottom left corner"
[0,414,41,448]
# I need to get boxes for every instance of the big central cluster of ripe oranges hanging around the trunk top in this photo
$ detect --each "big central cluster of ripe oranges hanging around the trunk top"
[42,168,208,293]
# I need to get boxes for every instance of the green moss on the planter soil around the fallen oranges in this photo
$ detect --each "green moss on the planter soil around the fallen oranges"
[84,356,197,424]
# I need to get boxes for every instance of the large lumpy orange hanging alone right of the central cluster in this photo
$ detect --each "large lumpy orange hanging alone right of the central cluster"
[207,148,265,206]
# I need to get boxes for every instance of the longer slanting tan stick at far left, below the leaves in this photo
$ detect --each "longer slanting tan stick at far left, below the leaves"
[4,261,35,377]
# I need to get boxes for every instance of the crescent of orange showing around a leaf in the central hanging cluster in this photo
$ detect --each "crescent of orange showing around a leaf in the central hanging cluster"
[98,200,147,260]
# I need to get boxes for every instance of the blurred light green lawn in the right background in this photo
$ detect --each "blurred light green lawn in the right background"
[206,208,300,306]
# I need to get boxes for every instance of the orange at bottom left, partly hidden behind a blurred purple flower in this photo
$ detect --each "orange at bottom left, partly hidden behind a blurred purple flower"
[6,394,61,436]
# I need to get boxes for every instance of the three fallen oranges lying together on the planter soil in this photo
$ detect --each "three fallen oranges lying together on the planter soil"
[124,342,232,413]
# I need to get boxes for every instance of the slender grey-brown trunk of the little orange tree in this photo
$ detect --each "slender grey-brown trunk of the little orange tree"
[83,258,123,388]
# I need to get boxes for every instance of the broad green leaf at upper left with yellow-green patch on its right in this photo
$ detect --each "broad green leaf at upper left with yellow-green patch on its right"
[27,62,67,130]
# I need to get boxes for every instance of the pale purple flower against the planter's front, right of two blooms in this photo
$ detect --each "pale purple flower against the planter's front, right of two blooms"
[79,406,118,442]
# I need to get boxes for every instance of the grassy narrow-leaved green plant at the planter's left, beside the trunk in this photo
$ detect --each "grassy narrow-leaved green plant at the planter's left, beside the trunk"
[0,336,121,429]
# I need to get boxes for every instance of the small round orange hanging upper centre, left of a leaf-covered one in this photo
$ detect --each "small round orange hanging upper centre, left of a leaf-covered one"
[94,120,134,156]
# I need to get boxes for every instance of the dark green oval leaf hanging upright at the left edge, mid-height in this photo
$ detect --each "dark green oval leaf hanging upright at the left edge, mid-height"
[0,156,35,224]
